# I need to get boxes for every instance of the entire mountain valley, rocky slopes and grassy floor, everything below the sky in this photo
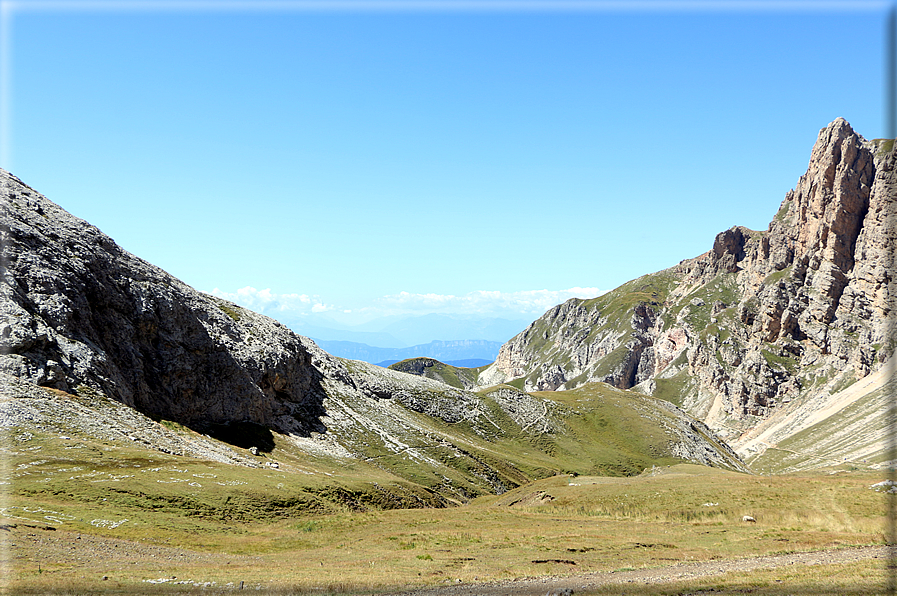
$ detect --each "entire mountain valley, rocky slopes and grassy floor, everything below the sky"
[0,118,897,596]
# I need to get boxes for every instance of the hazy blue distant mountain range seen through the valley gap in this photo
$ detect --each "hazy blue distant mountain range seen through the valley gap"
[312,338,502,366]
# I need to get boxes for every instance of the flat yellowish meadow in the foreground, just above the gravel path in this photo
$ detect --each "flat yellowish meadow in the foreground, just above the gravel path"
[8,464,885,593]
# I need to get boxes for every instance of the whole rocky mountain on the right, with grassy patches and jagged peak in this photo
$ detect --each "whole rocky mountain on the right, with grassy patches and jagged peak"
[481,118,897,442]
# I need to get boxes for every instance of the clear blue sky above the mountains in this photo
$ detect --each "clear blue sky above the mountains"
[0,1,888,326]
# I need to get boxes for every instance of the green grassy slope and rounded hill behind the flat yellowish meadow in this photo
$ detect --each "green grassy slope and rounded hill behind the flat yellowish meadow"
[5,385,736,545]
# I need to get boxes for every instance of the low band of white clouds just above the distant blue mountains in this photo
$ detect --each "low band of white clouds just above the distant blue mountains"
[210,286,605,320]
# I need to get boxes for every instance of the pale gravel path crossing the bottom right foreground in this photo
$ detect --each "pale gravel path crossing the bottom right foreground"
[395,546,892,596]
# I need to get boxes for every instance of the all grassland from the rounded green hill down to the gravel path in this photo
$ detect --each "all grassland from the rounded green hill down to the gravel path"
[0,372,886,594]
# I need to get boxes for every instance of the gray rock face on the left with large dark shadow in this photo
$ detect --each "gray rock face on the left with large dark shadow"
[0,171,323,430]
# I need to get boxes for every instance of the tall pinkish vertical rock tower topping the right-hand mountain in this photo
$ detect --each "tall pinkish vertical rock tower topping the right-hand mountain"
[746,119,880,358]
